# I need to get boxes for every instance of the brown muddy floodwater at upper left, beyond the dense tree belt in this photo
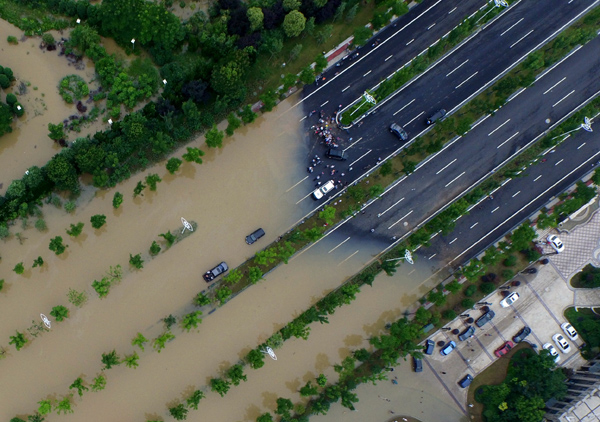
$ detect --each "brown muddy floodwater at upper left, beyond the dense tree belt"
[0,19,106,193]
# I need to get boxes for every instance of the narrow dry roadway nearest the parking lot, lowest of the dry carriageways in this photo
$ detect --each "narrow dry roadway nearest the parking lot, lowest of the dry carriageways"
[418,122,600,264]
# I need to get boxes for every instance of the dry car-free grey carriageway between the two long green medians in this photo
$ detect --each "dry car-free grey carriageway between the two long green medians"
[332,36,600,237]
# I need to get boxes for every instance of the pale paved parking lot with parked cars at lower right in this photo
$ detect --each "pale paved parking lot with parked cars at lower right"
[421,209,600,413]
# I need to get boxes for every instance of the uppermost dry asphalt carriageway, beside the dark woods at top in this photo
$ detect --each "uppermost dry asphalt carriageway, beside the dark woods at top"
[303,0,485,116]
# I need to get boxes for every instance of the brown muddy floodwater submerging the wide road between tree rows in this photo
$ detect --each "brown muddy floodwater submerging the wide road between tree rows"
[0,74,462,422]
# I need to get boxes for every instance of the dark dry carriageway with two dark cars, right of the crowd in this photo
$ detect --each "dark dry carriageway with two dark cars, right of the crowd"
[300,0,598,199]
